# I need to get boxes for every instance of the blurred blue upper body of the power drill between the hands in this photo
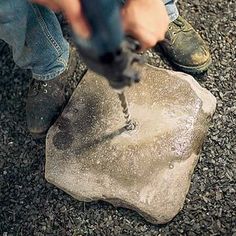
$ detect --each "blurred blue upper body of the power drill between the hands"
[76,0,124,57]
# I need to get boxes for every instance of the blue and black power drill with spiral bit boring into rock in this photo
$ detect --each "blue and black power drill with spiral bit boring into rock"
[75,0,143,130]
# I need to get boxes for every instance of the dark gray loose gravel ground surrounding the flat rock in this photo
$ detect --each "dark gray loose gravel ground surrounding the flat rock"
[0,0,236,236]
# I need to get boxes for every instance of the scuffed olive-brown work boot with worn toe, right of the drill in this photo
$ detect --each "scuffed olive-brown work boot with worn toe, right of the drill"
[160,16,212,74]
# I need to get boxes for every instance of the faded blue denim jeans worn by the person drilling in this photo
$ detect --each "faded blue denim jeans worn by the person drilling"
[0,0,178,80]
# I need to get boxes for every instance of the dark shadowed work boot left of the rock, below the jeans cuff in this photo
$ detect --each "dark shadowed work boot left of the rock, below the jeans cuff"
[26,48,77,138]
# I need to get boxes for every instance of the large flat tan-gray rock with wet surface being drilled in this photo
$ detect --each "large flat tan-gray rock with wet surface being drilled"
[45,65,216,223]
